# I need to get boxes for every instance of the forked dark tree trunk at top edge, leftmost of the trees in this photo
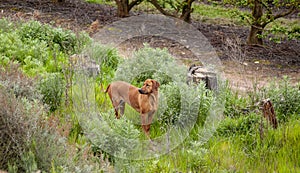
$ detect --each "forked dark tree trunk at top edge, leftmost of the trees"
[115,0,143,17]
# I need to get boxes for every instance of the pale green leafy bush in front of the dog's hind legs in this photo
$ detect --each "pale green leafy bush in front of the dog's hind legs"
[79,113,142,162]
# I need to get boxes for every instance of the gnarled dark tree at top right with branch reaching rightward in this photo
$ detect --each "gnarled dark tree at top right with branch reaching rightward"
[245,0,300,45]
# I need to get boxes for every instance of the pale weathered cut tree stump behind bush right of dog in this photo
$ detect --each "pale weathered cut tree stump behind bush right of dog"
[187,65,218,90]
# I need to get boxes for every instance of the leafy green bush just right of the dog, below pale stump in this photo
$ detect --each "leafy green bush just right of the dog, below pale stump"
[157,80,215,126]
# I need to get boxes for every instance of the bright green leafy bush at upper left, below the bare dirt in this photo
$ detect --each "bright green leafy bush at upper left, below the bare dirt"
[0,20,91,76]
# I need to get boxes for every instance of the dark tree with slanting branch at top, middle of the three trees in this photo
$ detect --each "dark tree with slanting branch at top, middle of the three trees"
[148,0,195,22]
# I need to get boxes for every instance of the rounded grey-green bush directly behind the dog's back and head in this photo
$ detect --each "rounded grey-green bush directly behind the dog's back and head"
[115,44,187,86]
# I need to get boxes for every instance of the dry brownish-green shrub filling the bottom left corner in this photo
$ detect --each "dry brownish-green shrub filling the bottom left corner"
[0,86,99,172]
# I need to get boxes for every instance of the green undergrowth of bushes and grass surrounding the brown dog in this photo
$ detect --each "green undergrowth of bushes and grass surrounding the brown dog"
[0,20,300,172]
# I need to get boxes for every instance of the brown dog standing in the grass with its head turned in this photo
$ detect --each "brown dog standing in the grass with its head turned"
[105,79,160,137]
